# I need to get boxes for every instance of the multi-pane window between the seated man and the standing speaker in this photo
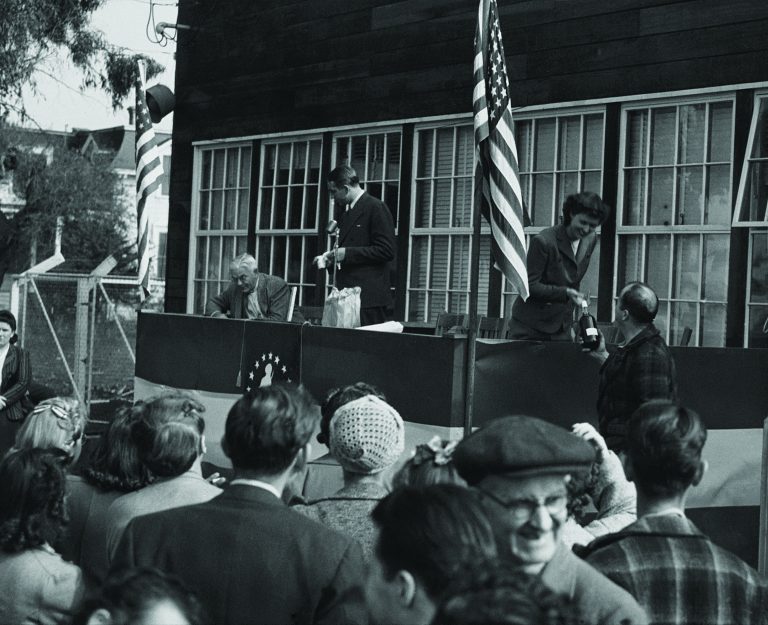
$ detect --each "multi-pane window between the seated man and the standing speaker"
[256,137,325,305]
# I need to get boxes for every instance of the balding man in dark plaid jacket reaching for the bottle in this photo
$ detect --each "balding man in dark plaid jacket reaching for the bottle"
[589,282,677,452]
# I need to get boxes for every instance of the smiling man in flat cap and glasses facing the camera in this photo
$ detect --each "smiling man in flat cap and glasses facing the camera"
[453,416,648,625]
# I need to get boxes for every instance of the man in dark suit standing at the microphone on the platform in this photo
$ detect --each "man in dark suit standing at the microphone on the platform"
[319,165,395,326]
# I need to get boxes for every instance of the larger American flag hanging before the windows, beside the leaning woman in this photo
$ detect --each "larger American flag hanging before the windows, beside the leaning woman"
[472,0,528,300]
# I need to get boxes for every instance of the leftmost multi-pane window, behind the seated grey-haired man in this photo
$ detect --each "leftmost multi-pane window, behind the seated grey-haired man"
[188,144,251,314]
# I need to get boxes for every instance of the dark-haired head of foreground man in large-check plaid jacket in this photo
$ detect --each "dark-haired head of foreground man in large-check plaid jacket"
[627,400,707,498]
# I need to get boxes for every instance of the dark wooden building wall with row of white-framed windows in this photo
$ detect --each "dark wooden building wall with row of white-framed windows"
[166,0,768,347]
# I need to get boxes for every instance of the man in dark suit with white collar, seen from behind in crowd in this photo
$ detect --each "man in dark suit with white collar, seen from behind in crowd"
[112,385,366,625]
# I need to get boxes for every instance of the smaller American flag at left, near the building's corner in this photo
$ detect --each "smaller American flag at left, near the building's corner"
[136,62,163,301]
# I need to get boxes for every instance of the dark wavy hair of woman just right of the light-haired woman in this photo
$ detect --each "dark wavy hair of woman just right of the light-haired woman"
[83,406,154,493]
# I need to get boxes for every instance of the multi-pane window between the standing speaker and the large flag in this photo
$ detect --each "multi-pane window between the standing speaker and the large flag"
[406,124,490,321]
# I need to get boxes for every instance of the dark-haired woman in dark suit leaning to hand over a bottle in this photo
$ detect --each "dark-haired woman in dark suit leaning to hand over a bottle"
[509,191,610,341]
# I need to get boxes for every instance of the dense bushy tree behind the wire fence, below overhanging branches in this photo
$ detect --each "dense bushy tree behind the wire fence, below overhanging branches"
[0,126,135,282]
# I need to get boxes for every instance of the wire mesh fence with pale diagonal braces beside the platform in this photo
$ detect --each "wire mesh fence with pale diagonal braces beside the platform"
[12,274,164,421]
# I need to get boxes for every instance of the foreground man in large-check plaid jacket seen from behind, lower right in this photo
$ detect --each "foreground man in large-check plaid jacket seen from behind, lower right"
[580,400,768,625]
